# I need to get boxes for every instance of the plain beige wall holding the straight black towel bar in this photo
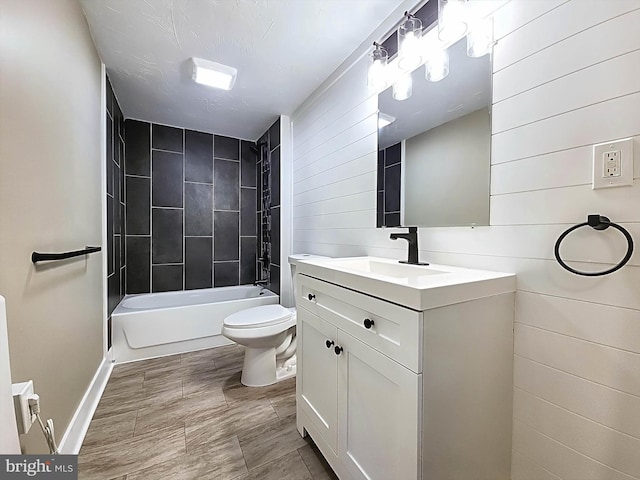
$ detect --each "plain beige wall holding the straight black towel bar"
[0,0,104,453]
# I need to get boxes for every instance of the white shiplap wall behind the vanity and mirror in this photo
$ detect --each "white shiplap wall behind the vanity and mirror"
[292,0,640,480]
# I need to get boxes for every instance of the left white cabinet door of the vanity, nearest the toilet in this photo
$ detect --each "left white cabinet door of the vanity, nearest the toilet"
[297,309,338,452]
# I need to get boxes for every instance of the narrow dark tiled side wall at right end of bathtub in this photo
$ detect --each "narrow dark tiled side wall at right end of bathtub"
[256,119,280,294]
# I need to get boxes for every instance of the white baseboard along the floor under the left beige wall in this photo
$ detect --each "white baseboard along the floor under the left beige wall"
[58,351,113,455]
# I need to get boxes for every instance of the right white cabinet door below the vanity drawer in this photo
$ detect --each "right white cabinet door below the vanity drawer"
[338,330,422,480]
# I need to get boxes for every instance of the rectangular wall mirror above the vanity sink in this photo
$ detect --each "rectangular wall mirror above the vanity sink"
[377,37,492,227]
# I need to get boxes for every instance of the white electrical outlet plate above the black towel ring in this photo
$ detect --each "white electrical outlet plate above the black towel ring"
[592,138,633,190]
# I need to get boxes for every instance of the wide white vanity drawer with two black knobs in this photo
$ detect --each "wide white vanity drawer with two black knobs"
[296,274,422,373]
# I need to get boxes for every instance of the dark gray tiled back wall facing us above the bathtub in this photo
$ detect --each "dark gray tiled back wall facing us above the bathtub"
[124,120,257,293]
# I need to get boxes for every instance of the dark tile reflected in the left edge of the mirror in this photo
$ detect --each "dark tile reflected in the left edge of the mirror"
[376,143,402,227]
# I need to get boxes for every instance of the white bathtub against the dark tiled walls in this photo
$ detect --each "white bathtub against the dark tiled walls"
[111,285,279,363]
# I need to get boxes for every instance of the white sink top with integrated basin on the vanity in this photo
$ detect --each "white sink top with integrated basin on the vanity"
[296,257,516,310]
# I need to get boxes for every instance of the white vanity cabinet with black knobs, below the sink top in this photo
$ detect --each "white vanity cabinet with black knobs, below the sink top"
[296,258,514,480]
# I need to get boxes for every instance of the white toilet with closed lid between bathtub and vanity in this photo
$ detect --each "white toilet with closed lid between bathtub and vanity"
[222,254,326,387]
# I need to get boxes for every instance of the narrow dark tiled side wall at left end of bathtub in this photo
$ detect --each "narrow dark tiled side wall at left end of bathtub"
[105,77,127,348]
